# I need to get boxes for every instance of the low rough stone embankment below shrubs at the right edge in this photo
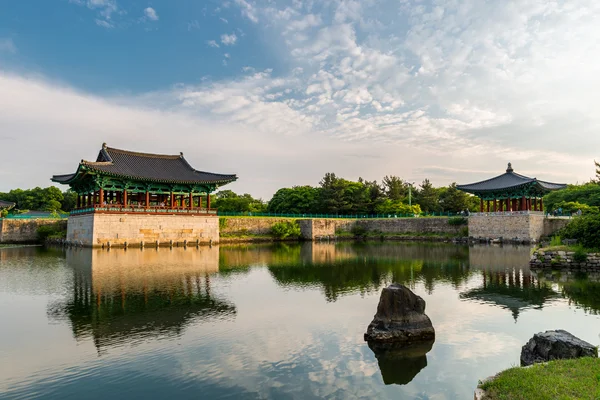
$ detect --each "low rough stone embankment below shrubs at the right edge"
[529,250,600,272]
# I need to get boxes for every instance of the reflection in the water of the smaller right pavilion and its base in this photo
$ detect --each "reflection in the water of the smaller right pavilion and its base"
[460,246,558,321]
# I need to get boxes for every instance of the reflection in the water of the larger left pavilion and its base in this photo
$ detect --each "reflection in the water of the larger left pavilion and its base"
[48,248,236,351]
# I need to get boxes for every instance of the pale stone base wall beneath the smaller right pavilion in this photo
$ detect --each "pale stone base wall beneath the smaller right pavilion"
[469,213,569,242]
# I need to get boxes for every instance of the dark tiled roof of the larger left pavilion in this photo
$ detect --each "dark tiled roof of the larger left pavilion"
[52,145,237,184]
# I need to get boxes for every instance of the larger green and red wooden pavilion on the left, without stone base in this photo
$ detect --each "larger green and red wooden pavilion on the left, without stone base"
[52,143,237,214]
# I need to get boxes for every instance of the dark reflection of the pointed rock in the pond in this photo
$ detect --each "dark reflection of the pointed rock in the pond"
[369,340,434,385]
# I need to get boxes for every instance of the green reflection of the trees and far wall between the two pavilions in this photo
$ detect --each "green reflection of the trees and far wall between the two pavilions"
[266,243,471,301]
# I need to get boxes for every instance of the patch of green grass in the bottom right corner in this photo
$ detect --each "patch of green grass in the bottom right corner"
[481,357,600,400]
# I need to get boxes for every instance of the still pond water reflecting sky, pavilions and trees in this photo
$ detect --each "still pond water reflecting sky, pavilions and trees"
[0,243,600,399]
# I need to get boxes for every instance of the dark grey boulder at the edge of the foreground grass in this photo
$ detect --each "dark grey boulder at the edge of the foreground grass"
[521,330,598,366]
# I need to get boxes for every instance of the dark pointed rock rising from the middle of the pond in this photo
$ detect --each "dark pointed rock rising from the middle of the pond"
[365,283,435,346]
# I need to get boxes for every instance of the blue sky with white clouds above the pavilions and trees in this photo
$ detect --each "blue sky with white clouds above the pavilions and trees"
[0,0,600,200]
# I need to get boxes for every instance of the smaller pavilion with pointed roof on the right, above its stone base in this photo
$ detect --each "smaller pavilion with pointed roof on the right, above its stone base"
[456,163,567,212]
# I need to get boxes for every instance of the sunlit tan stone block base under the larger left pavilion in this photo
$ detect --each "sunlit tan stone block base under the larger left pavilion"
[67,213,219,247]
